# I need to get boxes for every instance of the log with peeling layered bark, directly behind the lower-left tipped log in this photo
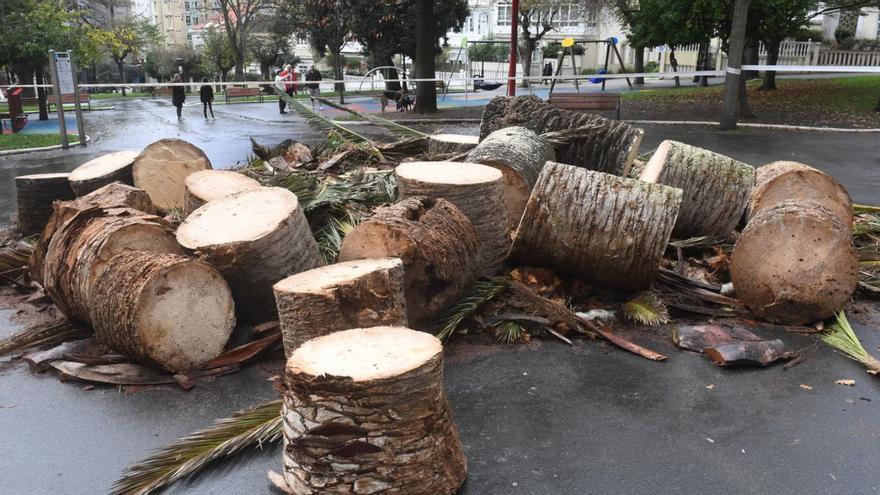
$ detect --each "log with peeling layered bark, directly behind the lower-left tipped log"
[43,208,183,324]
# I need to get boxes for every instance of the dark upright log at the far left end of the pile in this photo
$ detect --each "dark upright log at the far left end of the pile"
[15,174,76,234]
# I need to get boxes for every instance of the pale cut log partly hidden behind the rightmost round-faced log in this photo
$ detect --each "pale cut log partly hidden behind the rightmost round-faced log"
[749,161,853,227]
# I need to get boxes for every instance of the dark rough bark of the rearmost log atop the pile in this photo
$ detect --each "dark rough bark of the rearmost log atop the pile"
[480,95,644,177]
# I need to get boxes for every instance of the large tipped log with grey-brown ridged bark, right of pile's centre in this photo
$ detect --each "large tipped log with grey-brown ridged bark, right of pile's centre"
[511,162,682,292]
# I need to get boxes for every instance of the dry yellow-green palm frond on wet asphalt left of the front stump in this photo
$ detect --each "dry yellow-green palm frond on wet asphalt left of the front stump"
[110,400,281,495]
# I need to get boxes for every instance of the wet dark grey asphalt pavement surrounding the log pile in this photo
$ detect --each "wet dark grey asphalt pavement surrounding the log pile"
[0,101,880,495]
